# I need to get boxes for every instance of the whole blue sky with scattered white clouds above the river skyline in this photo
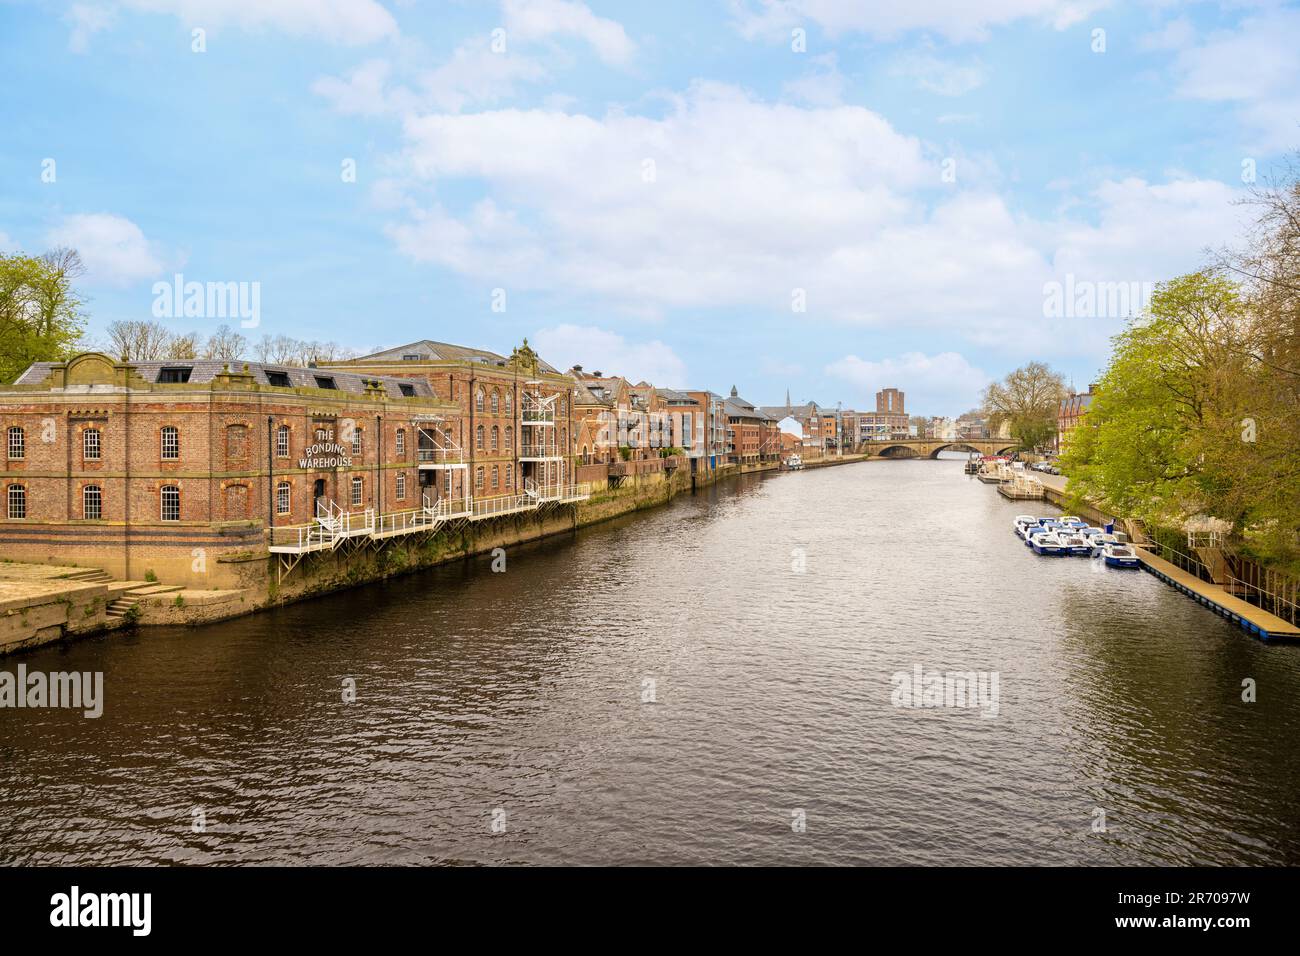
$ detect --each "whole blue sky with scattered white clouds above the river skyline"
[0,0,1300,414]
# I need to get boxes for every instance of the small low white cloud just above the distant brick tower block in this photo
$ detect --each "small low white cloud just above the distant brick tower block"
[826,352,989,408]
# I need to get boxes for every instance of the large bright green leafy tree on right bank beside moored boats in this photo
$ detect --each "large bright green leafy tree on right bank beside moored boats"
[1063,269,1300,564]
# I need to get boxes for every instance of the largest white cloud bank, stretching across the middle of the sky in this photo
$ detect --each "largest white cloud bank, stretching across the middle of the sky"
[374,85,1240,354]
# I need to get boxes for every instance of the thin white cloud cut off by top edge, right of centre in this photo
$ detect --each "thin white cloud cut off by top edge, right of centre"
[731,0,1106,42]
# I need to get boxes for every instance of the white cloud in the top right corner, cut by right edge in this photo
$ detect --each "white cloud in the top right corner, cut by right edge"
[1173,9,1300,151]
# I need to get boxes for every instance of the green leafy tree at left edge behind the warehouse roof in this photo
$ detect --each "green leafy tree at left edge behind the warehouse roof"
[0,248,85,382]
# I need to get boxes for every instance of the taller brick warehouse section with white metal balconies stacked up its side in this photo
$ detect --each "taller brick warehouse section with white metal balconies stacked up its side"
[330,339,577,497]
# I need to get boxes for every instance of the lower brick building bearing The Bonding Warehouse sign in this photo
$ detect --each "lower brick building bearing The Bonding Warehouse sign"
[0,352,458,588]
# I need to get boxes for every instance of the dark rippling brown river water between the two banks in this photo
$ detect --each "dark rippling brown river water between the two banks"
[0,459,1300,864]
